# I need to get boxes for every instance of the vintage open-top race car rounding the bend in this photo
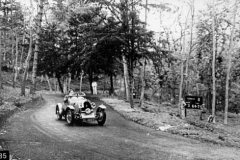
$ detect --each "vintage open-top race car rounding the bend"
[56,93,106,125]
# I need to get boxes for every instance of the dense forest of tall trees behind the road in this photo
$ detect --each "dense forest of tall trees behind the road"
[0,0,240,124]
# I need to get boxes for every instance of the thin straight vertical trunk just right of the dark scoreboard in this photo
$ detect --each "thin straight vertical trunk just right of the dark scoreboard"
[212,0,216,123]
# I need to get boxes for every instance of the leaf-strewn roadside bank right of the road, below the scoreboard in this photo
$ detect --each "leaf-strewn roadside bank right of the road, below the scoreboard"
[100,97,240,148]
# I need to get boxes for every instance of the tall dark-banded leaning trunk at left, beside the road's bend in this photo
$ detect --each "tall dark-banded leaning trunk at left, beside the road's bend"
[31,0,44,94]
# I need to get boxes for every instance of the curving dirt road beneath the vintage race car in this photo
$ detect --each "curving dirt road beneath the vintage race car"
[0,94,240,160]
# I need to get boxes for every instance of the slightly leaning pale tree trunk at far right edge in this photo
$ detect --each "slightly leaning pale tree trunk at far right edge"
[224,0,238,124]
